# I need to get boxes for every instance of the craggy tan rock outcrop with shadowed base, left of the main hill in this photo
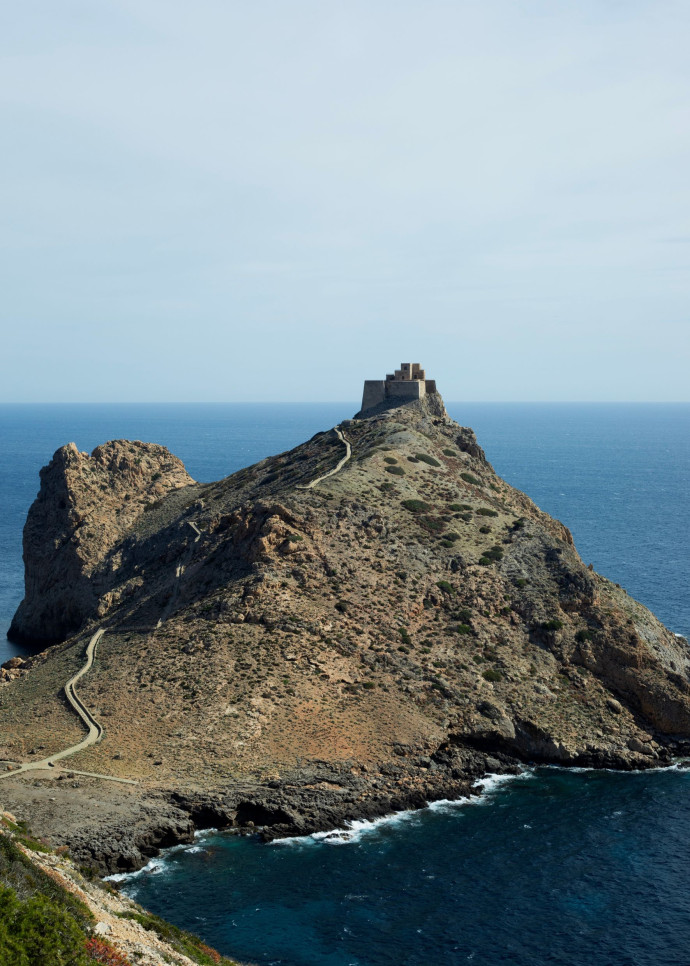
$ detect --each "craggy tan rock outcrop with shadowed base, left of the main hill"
[8,440,194,643]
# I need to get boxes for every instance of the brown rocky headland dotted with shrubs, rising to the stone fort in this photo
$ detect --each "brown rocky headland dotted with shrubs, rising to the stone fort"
[0,397,690,868]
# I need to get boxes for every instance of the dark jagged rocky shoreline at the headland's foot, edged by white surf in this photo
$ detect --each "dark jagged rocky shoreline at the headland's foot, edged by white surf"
[5,742,690,876]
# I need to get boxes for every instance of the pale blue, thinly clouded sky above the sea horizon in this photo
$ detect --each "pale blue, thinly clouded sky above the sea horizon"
[0,0,690,402]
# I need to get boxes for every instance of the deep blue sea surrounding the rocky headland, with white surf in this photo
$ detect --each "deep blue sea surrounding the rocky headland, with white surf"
[0,402,690,966]
